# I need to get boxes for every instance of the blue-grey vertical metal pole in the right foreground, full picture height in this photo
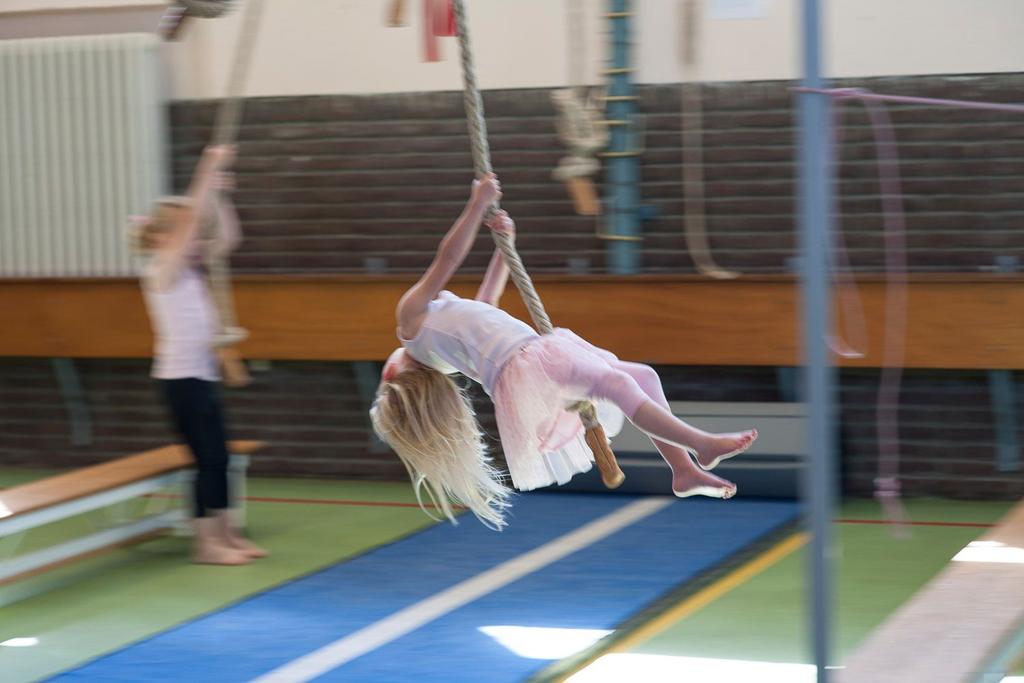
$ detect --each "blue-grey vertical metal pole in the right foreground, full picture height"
[799,0,834,683]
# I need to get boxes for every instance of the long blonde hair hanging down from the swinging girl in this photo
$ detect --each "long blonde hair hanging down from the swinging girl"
[370,365,512,529]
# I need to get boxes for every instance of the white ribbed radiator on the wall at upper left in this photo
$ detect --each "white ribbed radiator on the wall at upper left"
[0,34,168,278]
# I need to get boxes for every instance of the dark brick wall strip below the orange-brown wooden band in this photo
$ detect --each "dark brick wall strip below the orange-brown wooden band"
[0,358,1024,499]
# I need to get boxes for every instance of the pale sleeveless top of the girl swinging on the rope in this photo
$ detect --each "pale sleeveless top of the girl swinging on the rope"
[399,291,539,395]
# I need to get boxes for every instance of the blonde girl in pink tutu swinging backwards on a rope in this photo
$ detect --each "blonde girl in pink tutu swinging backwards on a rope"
[370,174,757,528]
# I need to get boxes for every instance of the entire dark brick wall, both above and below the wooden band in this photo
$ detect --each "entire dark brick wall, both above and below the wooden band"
[0,75,1024,498]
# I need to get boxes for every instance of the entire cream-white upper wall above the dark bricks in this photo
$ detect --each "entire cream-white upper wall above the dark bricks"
[0,0,1024,98]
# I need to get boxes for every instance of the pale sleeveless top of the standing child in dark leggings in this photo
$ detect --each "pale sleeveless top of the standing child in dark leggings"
[142,263,220,382]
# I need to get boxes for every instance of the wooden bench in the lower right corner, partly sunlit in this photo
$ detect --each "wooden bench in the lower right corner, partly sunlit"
[838,502,1024,683]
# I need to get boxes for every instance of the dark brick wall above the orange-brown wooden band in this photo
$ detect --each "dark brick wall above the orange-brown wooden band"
[173,75,1024,272]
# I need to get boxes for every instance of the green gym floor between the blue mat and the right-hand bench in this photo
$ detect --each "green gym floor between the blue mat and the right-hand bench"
[570,500,1024,683]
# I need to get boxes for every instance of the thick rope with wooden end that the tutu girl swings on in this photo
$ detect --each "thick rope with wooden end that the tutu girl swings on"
[453,0,625,488]
